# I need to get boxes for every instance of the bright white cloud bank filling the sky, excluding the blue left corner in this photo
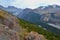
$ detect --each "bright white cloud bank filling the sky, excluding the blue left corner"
[12,0,60,8]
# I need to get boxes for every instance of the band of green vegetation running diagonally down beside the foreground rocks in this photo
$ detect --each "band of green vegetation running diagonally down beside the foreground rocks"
[19,19,60,40]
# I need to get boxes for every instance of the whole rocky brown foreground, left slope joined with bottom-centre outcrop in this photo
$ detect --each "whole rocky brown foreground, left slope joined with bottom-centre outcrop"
[0,10,46,40]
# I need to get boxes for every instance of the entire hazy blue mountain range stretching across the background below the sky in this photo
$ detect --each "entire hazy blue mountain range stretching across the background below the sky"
[0,5,60,29]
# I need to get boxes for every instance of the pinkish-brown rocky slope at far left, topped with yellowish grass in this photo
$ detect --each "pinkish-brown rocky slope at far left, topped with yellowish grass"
[0,10,20,40]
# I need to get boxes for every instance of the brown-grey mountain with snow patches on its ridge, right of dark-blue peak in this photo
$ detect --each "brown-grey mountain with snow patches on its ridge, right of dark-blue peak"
[34,5,60,25]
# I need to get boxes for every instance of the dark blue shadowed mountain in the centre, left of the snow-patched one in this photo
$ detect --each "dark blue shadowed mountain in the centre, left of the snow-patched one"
[18,8,40,22]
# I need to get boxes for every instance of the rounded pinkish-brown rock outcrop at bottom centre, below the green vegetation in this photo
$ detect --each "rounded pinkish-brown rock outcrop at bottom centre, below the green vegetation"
[24,32,47,40]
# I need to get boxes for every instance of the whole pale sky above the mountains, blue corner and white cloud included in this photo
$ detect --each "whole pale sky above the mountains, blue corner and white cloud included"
[0,0,60,8]
